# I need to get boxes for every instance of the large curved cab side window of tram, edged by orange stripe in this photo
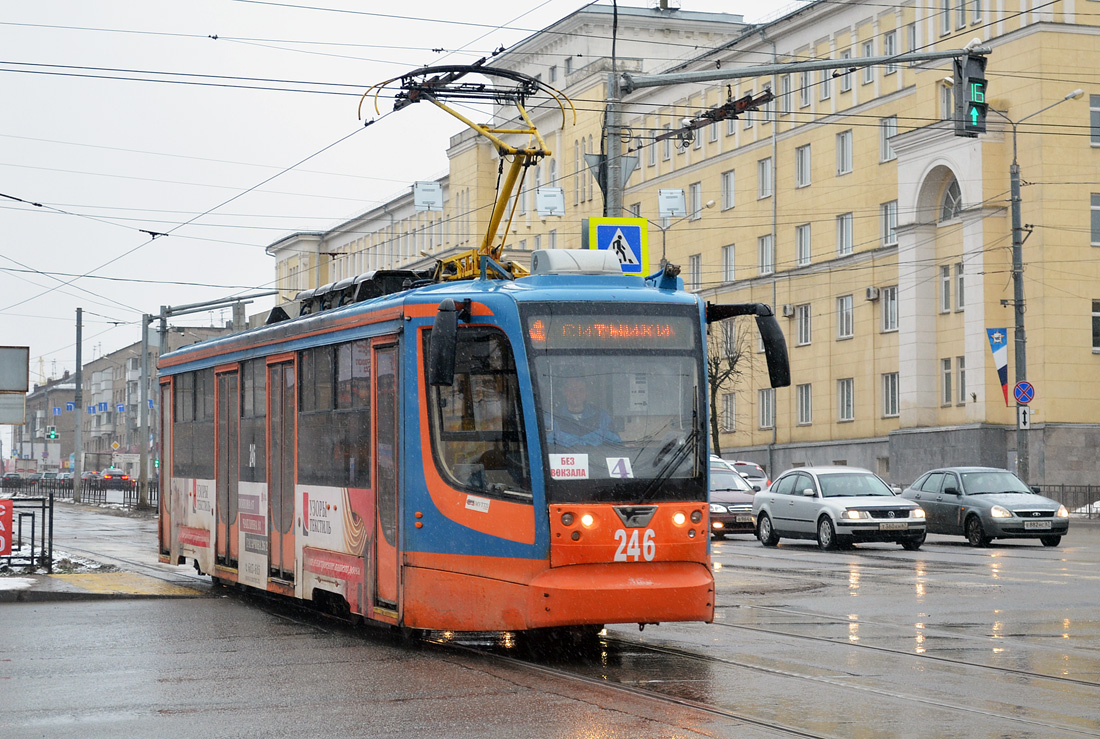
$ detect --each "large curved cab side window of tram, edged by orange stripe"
[424,327,531,499]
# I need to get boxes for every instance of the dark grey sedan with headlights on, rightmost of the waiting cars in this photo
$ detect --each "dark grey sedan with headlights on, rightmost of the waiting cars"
[902,467,1069,547]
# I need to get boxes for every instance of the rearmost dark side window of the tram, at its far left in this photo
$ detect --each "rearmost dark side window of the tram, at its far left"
[172,370,215,479]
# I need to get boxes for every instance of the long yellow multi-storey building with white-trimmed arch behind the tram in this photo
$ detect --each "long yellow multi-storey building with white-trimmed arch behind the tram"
[268,0,1100,485]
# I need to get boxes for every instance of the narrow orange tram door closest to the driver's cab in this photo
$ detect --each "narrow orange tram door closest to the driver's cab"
[374,344,398,611]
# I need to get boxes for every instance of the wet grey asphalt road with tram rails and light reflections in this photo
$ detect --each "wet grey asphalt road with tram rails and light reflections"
[0,501,1100,739]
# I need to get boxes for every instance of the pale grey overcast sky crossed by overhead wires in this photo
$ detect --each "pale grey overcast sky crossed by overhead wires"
[0,0,792,451]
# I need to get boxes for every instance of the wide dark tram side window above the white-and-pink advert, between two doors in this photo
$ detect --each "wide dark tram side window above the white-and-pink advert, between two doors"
[298,340,371,487]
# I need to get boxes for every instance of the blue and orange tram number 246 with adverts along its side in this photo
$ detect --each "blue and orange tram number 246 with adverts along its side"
[160,250,790,631]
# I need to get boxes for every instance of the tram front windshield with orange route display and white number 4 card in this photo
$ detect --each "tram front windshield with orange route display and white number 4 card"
[524,302,706,503]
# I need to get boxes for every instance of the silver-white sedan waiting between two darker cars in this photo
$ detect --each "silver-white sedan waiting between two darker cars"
[752,466,926,551]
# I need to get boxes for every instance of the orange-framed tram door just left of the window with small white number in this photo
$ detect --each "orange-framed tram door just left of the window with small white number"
[215,371,241,567]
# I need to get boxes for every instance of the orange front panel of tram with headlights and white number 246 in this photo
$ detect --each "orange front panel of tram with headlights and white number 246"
[550,501,708,567]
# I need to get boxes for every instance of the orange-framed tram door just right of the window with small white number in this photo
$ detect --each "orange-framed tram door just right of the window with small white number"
[267,355,297,581]
